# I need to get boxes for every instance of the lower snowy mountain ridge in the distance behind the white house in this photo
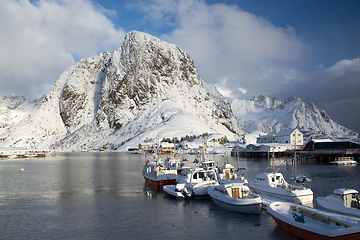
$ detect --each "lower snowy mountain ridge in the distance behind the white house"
[231,95,358,138]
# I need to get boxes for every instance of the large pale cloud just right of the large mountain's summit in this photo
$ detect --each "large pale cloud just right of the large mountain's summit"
[155,0,306,99]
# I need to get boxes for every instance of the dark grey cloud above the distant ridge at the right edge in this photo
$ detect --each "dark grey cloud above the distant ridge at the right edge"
[271,58,360,133]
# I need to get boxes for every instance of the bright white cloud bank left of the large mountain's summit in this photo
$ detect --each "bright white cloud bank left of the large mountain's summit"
[0,0,126,97]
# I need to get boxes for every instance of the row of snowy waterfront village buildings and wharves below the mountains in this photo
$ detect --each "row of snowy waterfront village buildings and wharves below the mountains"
[127,128,360,162]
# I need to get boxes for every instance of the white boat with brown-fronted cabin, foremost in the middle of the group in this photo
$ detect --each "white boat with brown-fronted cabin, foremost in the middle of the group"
[208,182,261,214]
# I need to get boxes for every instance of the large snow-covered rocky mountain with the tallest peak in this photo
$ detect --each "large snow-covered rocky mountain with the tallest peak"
[1,31,244,151]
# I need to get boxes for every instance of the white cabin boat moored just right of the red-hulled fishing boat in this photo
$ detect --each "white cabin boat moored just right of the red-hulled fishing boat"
[163,168,219,198]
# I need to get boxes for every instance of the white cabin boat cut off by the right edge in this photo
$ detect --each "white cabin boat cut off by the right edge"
[316,188,360,218]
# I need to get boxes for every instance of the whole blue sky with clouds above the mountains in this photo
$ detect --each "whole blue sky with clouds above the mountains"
[0,0,360,132]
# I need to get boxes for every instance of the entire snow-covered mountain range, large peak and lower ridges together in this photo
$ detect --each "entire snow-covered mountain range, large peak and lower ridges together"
[0,31,358,151]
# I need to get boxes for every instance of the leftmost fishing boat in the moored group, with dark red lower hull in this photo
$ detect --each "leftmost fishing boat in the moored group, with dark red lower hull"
[142,156,178,187]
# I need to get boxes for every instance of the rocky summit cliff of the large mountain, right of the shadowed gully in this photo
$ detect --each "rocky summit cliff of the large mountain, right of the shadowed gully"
[96,31,214,129]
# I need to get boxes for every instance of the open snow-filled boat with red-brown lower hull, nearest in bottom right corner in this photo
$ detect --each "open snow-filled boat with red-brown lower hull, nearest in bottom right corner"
[267,202,360,240]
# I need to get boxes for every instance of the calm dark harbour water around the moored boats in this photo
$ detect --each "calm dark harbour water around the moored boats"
[0,152,360,239]
